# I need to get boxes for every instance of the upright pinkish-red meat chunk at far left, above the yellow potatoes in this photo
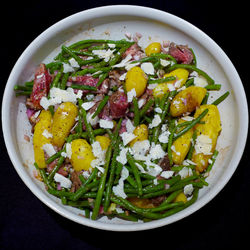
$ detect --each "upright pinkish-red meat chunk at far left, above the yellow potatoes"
[30,63,52,110]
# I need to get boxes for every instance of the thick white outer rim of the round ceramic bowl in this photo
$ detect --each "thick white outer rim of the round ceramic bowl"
[2,5,248,231]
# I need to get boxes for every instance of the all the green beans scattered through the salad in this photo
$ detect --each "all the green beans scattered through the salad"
[14,39,229,222]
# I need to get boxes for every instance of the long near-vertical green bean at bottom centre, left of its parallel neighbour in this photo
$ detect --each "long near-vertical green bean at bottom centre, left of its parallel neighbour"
[91,145,112,220]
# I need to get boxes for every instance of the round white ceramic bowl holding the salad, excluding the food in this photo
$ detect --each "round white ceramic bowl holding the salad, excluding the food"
[2,5,248,231]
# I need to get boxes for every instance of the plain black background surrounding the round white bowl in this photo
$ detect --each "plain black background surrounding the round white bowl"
[0,0,250,250]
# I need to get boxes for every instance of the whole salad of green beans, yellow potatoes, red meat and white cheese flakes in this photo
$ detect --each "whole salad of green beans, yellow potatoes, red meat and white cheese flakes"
[15,36,229,222]
